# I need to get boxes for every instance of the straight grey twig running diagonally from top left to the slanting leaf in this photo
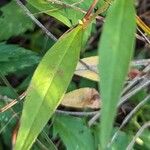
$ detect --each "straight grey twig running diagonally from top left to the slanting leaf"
[15,0,57,41]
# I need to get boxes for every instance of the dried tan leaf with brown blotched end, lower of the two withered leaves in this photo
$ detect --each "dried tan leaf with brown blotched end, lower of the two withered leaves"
[61,88,101,109]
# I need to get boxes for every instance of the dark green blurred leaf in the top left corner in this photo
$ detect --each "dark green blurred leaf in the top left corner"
[0,1,33,40]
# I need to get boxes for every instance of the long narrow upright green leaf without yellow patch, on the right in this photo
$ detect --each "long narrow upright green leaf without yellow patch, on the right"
[99,0,136,149]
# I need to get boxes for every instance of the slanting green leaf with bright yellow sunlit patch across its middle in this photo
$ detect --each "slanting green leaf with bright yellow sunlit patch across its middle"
[15,26,83,150]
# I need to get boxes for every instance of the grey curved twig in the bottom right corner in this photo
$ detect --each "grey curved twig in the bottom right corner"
[126,121,150,150]
